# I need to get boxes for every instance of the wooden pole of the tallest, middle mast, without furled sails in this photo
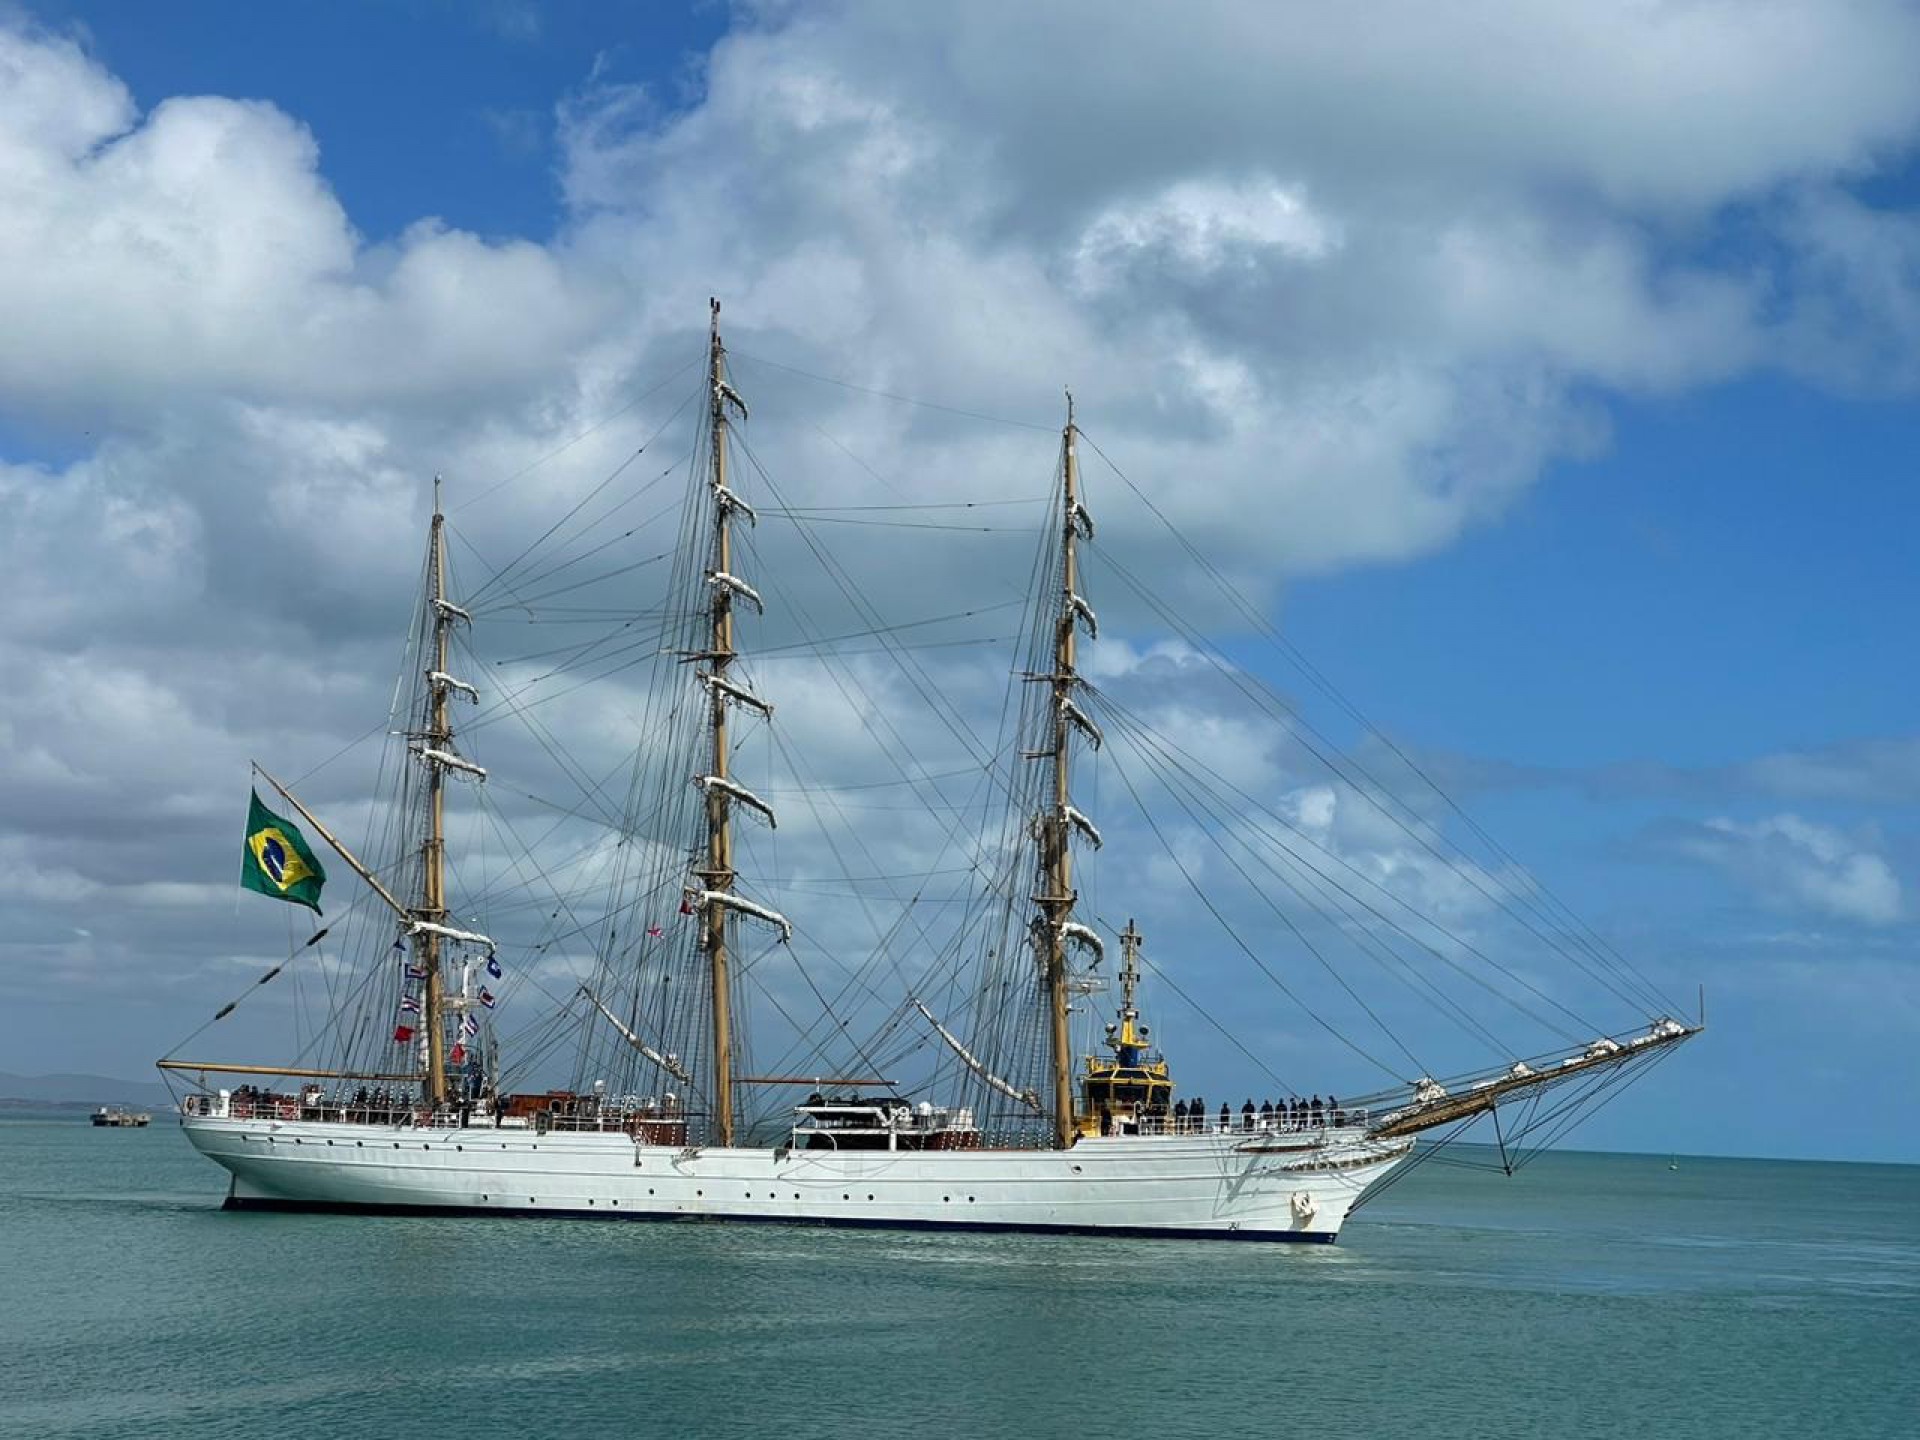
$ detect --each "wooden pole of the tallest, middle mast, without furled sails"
[701,300,733,1144]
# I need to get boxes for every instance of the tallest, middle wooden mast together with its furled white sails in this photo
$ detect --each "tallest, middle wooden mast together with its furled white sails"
[689,300,793,1144]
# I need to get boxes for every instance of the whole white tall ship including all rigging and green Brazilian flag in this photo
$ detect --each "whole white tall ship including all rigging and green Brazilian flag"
[159,303,1699,1242]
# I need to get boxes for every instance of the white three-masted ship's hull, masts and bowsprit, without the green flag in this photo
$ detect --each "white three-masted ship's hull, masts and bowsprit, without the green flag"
[159,303,1697,1240]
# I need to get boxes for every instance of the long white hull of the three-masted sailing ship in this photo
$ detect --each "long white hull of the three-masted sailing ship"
[180,1116,1413,1240]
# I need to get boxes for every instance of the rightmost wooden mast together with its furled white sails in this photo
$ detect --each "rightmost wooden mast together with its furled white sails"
[1035,394,1100,1148]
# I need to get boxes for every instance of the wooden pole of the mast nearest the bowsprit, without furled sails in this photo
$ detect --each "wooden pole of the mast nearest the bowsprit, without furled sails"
[1041,392,1081,1148]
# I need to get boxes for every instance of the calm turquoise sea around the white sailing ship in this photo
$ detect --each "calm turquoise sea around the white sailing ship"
[0,1112,1920,1440]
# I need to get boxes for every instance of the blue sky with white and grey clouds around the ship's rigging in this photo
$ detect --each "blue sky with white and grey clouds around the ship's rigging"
[0,0,1920,1162]
